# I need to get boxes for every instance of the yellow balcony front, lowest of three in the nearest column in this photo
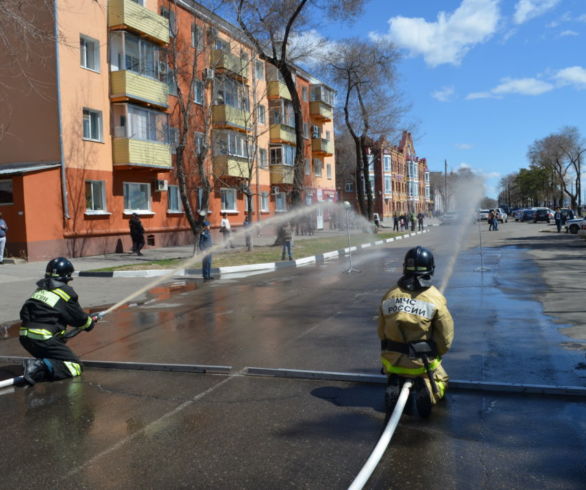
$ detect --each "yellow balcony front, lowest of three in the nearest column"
[112,138,171,171]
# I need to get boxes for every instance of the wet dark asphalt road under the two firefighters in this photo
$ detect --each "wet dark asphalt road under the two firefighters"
[0,223,586,489]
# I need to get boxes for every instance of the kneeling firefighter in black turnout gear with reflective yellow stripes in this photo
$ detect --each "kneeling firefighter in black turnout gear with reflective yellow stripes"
[20,257,98,385]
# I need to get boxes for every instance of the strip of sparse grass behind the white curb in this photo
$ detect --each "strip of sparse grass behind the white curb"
[95,232,403,272]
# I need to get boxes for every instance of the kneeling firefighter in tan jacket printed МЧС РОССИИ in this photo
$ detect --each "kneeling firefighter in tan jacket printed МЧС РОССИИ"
[378,247,454,417]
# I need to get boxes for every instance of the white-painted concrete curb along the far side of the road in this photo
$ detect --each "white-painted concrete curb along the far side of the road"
[73,229,429,278]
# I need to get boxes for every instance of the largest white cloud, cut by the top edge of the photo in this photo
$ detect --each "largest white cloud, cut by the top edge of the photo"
[371,0,500,66]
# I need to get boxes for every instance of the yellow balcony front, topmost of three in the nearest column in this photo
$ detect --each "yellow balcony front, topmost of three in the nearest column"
[108,0,169,44]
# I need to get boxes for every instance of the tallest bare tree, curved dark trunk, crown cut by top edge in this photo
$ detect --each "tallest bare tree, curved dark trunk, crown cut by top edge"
[231,0,364,205]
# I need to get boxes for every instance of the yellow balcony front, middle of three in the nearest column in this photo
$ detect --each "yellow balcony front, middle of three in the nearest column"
[110,70,168,108]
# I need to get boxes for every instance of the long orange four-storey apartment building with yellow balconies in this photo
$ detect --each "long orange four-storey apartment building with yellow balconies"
[0,0,337,260]
